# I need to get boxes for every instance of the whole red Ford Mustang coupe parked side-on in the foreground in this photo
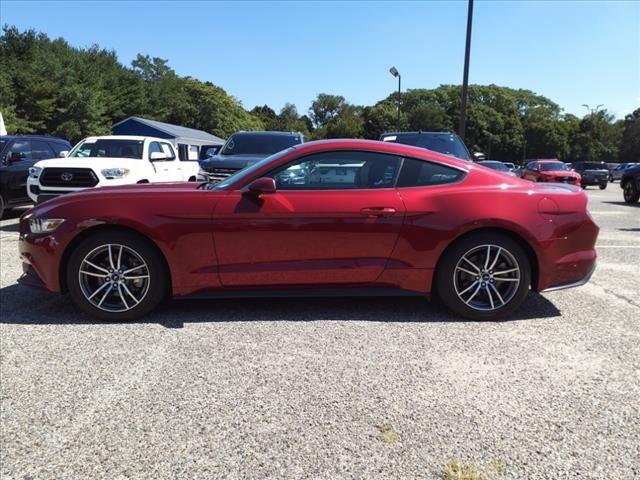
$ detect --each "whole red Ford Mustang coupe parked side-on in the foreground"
[20,140,598,320]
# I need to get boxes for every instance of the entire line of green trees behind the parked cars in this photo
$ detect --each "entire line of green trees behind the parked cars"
[0,27,640,163]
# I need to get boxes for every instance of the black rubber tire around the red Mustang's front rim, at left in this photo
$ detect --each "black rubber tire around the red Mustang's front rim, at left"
[66,230,169,322]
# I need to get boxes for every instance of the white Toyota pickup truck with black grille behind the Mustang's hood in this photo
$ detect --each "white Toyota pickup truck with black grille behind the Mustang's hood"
[27,135,198,203]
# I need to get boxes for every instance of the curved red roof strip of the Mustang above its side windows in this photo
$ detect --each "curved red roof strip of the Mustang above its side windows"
[291,138,472,169]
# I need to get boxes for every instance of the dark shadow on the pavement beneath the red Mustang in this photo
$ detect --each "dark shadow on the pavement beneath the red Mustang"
[0,284,562,328]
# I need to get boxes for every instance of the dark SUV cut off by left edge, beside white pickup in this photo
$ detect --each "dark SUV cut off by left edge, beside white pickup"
[0,135,71,218]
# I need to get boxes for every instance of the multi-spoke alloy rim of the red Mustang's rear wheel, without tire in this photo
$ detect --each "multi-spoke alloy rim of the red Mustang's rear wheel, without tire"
[453,245,520,311]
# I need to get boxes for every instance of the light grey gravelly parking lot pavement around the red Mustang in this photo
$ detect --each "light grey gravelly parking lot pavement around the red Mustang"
[0,184,640,479]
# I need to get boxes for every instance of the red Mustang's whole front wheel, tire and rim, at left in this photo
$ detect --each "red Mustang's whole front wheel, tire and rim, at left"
[67,231,168,321]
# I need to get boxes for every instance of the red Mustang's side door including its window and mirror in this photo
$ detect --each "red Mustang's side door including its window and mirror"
[213,151,405,287]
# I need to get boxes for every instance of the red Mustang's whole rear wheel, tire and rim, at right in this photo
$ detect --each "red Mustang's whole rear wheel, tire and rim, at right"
[436,233,531,320]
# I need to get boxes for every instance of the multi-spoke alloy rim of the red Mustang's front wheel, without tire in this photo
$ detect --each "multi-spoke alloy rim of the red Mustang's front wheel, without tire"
[78,243,150,313]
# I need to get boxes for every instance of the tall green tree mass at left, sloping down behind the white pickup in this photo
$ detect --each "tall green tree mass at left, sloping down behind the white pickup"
[0,27,264,142]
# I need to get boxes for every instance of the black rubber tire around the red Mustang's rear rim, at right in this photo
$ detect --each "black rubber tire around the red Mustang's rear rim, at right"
[436,232,531,320]
